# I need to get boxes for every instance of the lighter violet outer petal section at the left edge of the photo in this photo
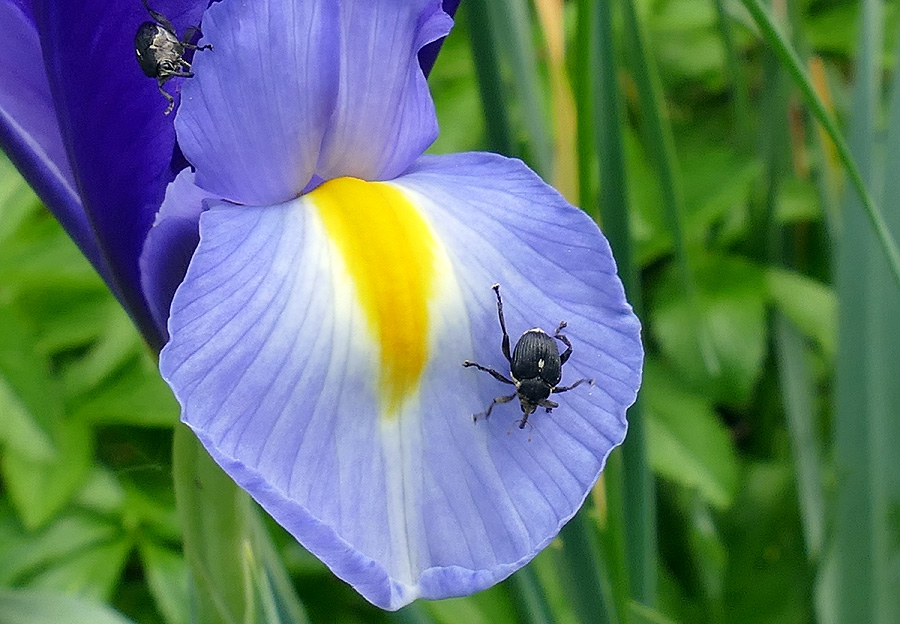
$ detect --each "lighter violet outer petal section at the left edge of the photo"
[0,0,115,287]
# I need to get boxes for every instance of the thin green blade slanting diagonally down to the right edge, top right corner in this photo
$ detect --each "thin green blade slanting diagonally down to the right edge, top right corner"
[741,0,900,285]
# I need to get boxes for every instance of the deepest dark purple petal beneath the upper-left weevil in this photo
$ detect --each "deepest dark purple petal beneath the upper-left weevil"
[34,0,207,346]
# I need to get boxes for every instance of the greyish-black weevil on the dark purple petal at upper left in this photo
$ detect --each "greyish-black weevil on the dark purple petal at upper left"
[134,0,212,115]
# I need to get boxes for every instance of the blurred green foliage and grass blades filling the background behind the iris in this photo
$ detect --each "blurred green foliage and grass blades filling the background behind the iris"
[0,0,900,624]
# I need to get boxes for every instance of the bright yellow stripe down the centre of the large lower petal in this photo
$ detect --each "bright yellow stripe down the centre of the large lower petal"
[307,178,436,415]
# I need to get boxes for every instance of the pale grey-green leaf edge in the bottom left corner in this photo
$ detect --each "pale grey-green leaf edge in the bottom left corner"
[0,589,134,624]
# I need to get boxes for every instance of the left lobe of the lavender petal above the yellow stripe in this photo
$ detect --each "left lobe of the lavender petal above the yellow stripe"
[176,0,339,205]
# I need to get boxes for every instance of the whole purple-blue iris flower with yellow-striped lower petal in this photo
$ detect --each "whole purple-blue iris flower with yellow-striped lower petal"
[0,0,642,609]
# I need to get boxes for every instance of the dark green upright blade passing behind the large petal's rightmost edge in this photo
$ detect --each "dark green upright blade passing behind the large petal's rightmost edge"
[594,1,656,612]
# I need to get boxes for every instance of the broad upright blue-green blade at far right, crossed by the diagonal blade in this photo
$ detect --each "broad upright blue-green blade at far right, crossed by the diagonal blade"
[832,0,897,624]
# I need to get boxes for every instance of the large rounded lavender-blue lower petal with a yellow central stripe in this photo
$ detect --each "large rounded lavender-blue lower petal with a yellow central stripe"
[160,154,642,609]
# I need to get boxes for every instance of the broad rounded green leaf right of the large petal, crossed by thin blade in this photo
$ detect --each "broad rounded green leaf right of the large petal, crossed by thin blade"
[651,256,766,405]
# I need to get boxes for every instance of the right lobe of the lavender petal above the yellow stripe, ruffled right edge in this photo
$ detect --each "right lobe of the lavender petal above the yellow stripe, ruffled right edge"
[316,0,453,180]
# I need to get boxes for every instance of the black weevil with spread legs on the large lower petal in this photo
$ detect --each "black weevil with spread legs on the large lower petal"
[463,284,594,429]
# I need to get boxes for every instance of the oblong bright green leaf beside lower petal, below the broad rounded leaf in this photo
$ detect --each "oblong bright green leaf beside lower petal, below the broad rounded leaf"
[641,359,739,509]
